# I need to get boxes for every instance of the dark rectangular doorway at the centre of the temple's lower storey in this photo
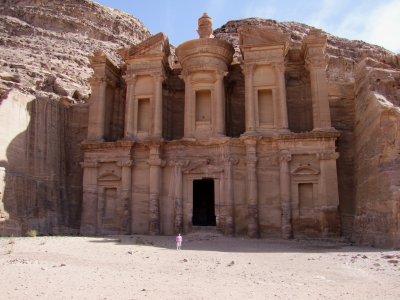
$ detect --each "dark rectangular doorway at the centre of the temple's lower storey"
[192,178,216,226]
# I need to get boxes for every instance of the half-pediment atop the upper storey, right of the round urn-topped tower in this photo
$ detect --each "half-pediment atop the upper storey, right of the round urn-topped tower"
[238,25,290,48]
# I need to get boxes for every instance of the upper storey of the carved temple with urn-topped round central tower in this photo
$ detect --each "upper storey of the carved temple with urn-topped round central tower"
[88,14,333,141]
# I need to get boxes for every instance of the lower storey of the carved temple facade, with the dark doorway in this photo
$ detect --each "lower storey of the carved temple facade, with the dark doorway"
[80,132,340,238]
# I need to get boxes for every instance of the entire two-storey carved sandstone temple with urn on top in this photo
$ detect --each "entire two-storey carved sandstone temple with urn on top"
[80,14,340,238]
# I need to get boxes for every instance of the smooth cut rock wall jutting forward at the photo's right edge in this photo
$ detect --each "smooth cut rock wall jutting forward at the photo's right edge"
[353,59,400,247]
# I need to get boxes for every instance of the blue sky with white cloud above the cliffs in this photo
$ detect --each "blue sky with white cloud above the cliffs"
[94,0,400,53]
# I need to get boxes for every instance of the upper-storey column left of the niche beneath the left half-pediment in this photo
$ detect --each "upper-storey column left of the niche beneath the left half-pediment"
[124,75,136,139]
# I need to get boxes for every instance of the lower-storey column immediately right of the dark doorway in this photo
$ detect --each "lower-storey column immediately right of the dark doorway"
[224,156,238,236]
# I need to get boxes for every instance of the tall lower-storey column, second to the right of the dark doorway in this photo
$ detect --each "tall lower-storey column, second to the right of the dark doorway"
[245,139,259,238]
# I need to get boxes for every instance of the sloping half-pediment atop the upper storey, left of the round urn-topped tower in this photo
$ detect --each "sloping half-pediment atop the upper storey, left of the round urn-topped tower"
[118,32,170,60]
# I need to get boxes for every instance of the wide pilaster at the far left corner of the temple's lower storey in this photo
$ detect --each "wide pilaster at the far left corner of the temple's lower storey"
[80,161,98,235]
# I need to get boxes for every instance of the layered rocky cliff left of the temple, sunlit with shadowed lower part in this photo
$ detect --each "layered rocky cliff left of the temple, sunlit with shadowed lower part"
[0,0,150,234]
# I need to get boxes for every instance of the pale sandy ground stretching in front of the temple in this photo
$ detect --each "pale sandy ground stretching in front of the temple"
[0,233,400,299]
